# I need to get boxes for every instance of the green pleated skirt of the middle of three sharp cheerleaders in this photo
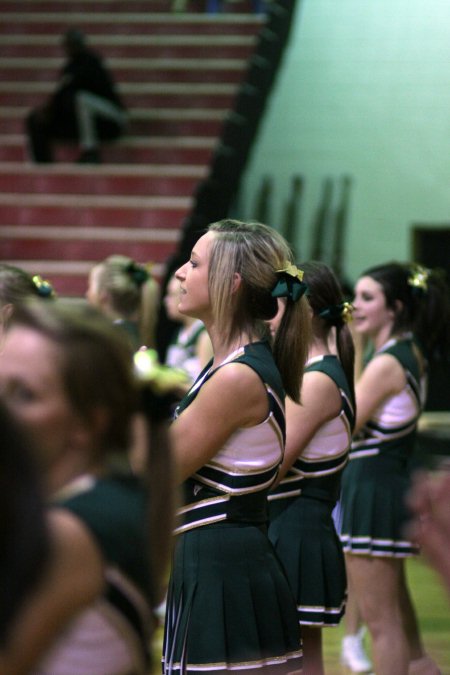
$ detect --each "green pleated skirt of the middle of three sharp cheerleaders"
[269,496,347,627]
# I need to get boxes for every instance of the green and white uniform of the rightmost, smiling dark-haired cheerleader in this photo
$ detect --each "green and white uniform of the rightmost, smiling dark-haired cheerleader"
[341,336,425,557]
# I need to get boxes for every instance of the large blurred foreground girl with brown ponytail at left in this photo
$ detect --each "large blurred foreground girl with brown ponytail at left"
[0,300,171,675]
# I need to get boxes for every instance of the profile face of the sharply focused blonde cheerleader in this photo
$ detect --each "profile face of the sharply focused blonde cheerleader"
[175,232,216,319]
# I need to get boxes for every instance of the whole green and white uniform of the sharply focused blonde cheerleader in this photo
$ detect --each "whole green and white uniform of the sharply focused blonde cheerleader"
[163,342,302,675]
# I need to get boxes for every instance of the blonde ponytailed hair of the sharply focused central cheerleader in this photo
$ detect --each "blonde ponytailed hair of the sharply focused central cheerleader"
[208,219,311,401]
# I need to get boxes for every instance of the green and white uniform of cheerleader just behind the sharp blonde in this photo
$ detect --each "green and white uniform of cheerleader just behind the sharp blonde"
[269,355,354,627]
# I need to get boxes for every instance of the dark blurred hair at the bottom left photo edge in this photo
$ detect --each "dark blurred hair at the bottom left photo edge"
[0,403,48,646]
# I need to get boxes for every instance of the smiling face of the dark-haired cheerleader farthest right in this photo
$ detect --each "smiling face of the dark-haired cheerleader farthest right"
[353,277,395,337]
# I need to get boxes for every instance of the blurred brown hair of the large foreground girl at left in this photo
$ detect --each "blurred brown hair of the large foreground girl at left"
[12,300,137,453]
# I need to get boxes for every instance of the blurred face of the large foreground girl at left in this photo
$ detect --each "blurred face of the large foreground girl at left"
[0,326,87,471]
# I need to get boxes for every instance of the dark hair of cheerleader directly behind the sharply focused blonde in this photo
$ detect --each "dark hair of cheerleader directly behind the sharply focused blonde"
[300,260,355,400]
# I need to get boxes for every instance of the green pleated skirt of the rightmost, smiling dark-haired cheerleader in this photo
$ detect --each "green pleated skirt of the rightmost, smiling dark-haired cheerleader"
[340,454,419,558]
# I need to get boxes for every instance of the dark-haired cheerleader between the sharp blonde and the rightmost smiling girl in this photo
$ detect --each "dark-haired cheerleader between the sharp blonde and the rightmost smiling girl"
[269,262,355,675]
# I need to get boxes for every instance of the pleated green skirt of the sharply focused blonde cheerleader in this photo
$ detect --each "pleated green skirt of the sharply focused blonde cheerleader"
[163,522,302,675]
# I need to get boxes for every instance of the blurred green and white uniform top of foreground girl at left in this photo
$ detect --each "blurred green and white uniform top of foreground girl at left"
[37,475,152,675]
